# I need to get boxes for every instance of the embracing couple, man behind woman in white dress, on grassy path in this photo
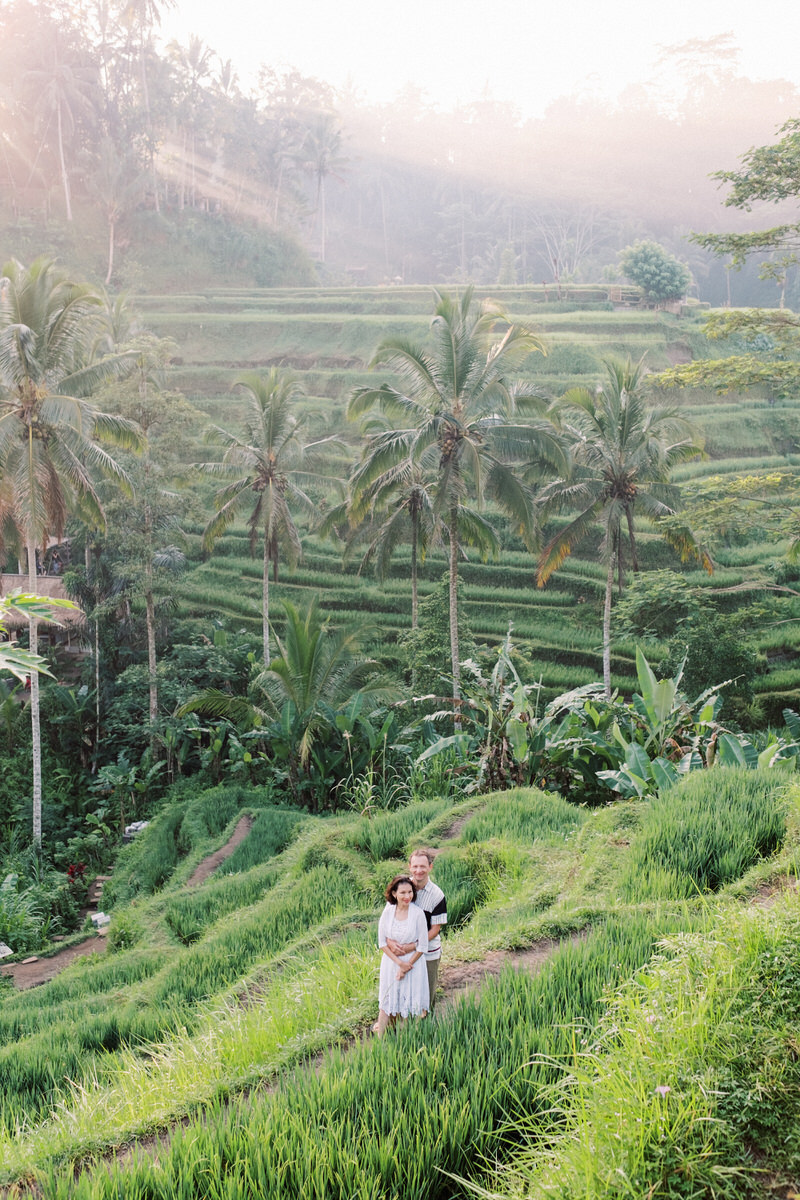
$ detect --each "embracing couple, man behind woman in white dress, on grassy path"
[373,850,447,1036]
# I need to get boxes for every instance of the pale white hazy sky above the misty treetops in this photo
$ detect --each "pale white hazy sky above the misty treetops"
[162,0,800,116]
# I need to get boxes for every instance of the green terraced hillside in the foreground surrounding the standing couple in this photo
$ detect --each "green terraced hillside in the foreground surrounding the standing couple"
[0,769,800,1200]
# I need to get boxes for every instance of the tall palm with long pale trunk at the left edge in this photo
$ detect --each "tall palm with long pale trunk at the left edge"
[0,258,139,845]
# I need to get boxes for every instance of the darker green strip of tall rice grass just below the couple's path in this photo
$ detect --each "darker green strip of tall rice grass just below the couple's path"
[38,916,700,1200]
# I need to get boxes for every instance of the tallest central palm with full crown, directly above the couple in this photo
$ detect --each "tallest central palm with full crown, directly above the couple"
[348,287,566,712]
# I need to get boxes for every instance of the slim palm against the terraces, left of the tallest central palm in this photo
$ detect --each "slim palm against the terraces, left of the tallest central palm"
[199,367,338,664]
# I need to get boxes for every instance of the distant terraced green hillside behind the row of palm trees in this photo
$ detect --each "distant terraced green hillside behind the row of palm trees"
[140,288,800,718]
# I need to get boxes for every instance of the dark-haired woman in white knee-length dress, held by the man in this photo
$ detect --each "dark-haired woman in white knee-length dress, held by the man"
[373,875,428,1036]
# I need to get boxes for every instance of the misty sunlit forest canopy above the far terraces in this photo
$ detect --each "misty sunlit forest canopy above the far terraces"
[0,0,800,304]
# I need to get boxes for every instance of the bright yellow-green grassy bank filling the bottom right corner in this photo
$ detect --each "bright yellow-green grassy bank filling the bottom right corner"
[492,908,800,1200]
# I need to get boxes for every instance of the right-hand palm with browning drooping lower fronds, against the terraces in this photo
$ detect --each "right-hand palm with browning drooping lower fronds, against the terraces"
[536,359,711,696]
